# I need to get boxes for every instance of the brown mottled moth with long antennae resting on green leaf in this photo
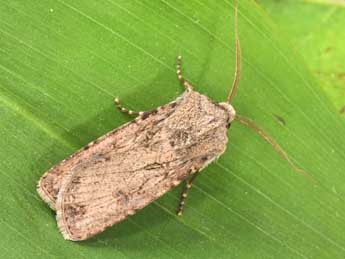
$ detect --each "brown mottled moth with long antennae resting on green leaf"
[38,3,310,241]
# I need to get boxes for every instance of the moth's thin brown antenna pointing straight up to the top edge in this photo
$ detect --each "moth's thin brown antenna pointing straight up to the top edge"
[226,0,241,103]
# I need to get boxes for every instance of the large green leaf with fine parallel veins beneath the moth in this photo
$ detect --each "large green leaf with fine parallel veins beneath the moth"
[0,0,345,258]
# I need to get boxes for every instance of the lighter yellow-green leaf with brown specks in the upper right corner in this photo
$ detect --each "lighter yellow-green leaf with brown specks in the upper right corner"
[260,0,345,114]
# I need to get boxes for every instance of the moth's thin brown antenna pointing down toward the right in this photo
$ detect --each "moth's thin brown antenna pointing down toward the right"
[235,115,317,184]
